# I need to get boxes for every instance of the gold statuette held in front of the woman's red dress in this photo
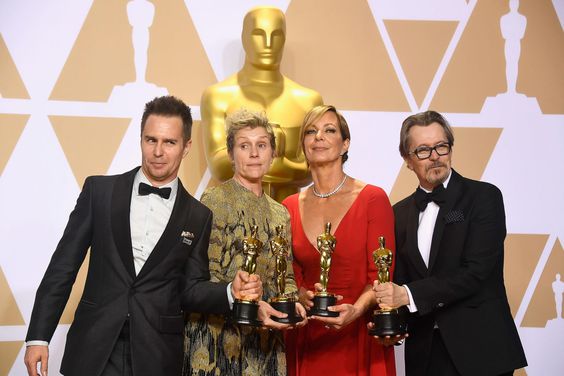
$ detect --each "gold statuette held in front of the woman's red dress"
[309,222,339,317]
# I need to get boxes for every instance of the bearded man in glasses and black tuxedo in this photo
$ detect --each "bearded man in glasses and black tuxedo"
[374,111,527,376]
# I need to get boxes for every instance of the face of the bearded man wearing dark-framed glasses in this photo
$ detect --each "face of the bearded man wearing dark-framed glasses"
[404,123,452,190]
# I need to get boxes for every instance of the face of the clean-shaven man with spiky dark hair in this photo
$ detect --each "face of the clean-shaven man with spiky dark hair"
[141,115,192,186]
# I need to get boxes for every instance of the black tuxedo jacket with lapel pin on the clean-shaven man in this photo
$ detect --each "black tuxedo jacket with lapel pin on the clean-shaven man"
[26,168,229,376]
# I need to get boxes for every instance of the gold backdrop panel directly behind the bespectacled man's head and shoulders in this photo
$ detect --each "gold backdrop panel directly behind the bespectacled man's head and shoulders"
[390,127,502,203]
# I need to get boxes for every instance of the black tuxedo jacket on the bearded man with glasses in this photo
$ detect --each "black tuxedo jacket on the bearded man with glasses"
[394,170,527,376]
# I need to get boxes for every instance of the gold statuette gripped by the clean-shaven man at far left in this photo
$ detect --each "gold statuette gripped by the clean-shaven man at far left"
[233,221,263,326]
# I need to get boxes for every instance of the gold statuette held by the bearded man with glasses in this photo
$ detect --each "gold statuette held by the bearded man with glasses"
[368,236,407,337]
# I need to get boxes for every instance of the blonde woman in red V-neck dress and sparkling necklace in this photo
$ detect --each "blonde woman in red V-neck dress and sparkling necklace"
[283,106,395,376]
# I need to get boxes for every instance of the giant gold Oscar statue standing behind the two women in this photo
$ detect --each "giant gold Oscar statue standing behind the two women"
[200,7,323,201]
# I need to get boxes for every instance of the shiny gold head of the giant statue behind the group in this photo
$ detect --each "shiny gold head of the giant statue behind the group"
[241,8,286,69]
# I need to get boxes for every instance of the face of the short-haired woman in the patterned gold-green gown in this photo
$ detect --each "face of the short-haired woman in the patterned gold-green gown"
[230,127,274,186]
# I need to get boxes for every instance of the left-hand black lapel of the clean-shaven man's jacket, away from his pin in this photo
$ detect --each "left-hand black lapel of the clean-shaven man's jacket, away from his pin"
[111,167,139,279]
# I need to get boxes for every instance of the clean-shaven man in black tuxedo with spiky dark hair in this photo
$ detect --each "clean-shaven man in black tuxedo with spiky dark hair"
[25,96,262,376]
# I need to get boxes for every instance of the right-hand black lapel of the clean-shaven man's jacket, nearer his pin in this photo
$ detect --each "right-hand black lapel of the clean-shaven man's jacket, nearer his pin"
[137,180,191,279]
